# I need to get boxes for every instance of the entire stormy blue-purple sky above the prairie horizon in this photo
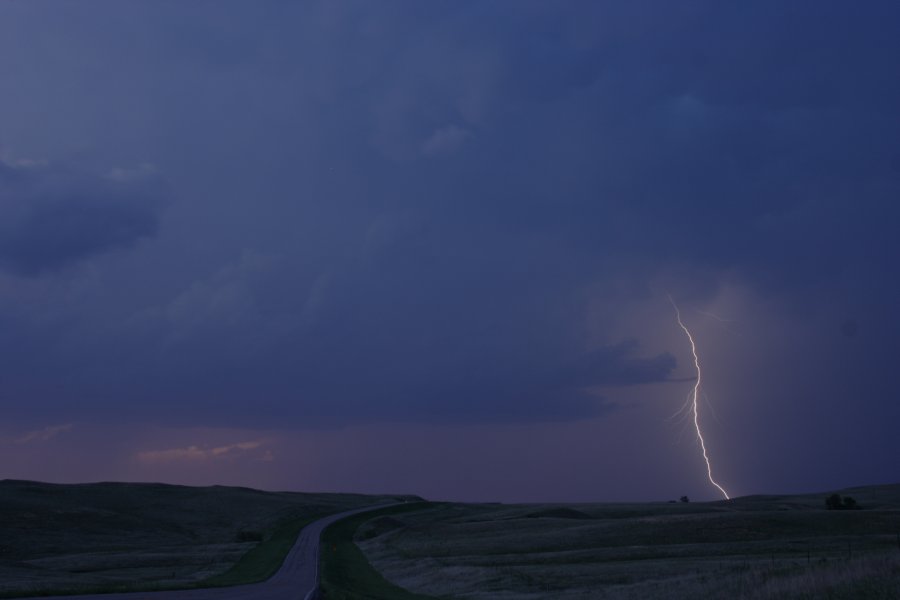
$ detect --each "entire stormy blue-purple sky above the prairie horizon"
[0,0,900,501]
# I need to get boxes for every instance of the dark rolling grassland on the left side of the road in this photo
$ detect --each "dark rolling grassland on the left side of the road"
[0,481,414,597]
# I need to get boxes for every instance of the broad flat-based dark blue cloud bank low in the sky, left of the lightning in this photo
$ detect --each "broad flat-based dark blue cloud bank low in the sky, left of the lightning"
[61,241,675,425]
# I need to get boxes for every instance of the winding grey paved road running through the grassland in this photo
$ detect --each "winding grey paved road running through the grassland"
[20,504,391,600]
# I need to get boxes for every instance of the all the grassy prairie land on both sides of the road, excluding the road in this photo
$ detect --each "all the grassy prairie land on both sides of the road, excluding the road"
[0,481,900,600]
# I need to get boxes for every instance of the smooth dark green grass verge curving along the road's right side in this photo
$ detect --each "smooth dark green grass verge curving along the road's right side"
[320,502,433,600]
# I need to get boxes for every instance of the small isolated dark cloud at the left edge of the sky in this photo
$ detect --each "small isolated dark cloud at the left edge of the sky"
[0,162,161,275]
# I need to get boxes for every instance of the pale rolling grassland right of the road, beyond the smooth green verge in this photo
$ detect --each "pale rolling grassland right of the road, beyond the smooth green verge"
[355,485,900,600]
